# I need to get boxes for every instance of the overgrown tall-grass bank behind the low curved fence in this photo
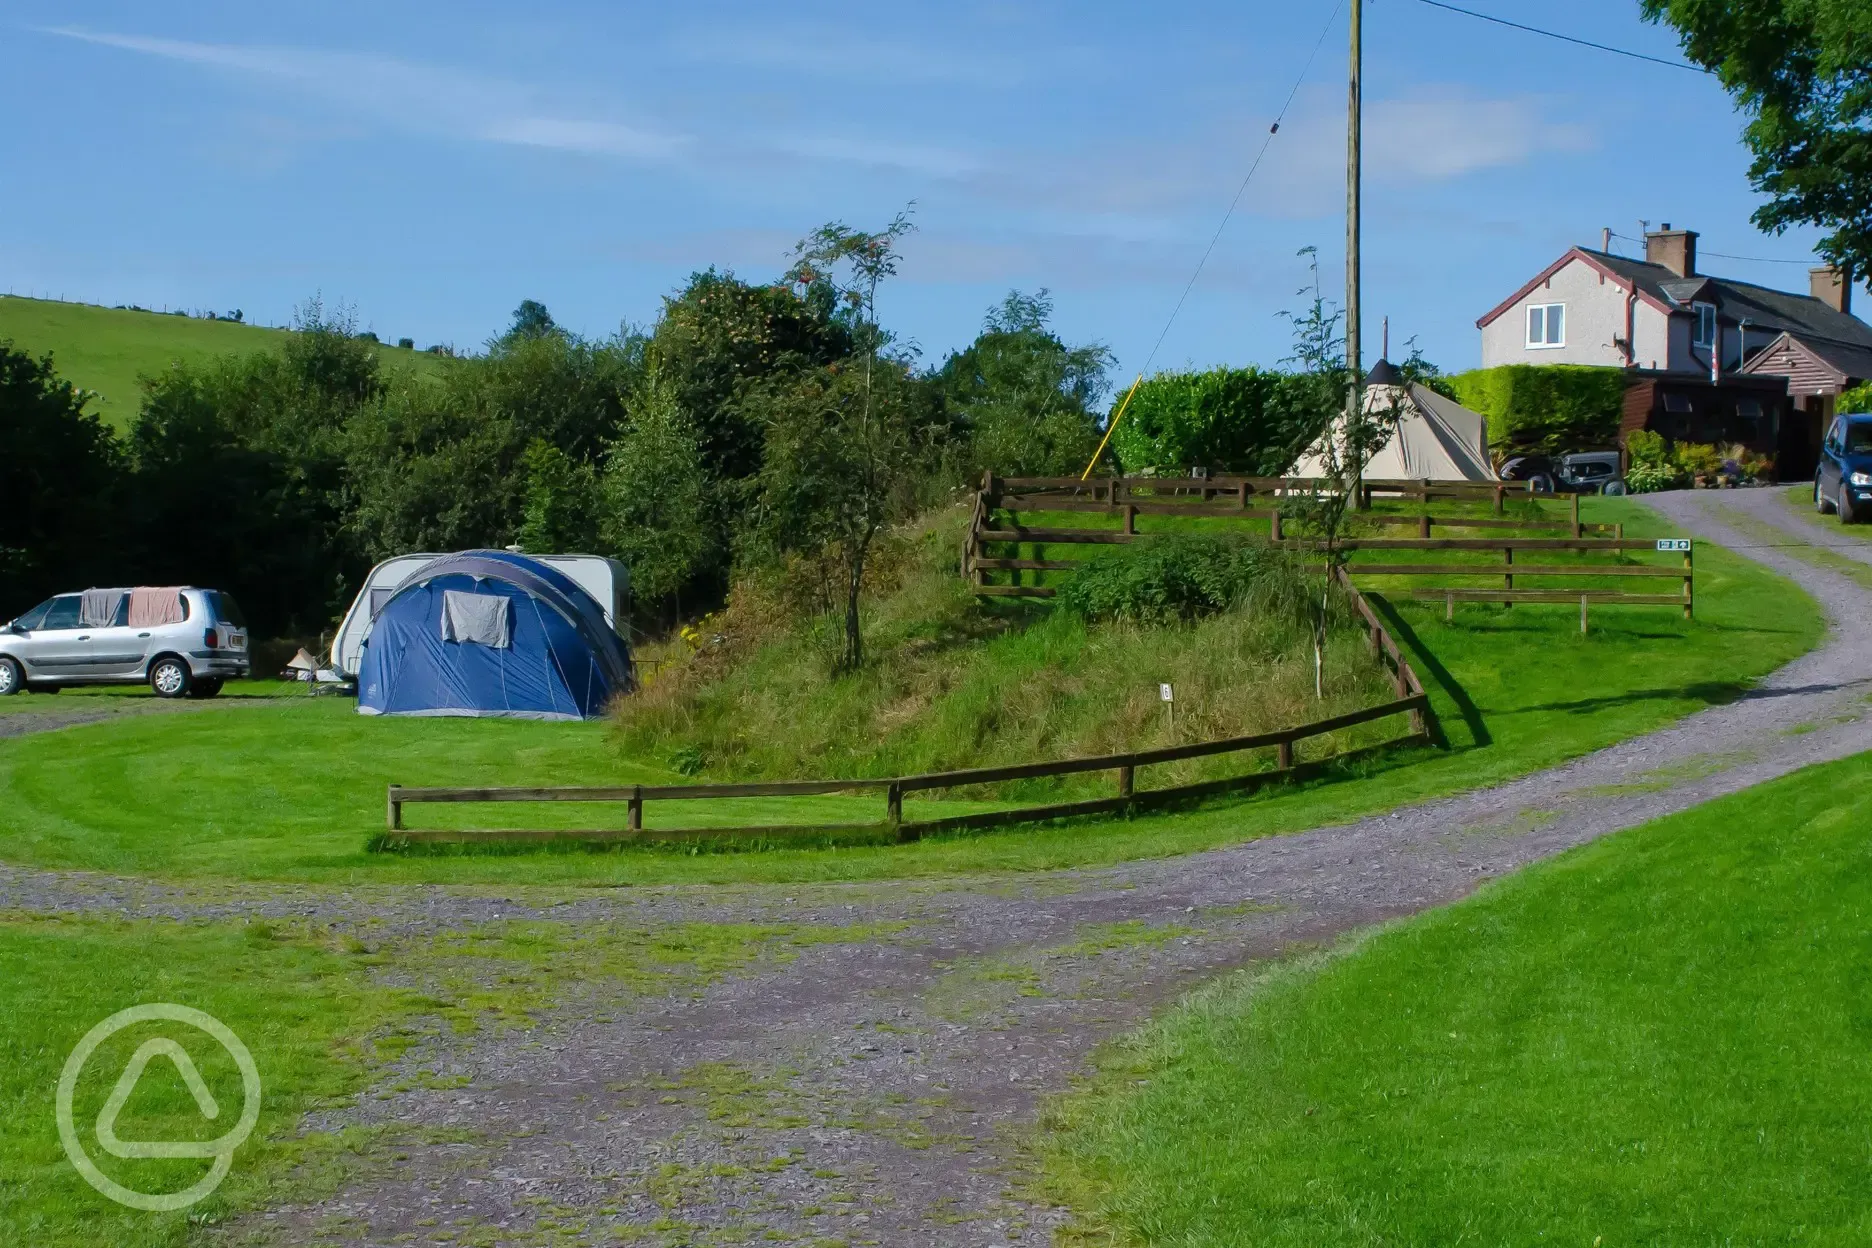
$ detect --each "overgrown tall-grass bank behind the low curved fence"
[616,513,1397,795]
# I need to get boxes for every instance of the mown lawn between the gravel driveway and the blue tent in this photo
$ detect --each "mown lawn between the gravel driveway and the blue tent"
[0,500,1823,887]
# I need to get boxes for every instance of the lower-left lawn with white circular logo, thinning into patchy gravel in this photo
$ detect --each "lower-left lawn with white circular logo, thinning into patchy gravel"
[0,915,878,1248]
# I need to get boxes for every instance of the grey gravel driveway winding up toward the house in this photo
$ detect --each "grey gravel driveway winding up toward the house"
[0,490,1872,1246]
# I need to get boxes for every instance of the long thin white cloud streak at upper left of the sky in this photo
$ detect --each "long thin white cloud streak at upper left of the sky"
[43,26,689,159]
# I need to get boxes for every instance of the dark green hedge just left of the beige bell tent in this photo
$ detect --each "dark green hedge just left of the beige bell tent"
[1112,369,1337,477]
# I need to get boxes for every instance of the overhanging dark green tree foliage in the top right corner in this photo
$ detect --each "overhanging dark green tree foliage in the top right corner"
[1640,0,1872,279]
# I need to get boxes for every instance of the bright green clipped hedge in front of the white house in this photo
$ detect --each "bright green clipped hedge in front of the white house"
[1451,365,1625,455]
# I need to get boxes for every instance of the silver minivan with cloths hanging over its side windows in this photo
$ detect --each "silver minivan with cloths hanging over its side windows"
[0,588,251,698]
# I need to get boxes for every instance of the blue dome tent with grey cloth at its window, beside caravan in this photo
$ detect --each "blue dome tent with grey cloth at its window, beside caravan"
[358,550,631,718]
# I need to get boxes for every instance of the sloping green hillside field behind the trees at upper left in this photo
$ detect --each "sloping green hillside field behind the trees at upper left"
[0,296,434,430]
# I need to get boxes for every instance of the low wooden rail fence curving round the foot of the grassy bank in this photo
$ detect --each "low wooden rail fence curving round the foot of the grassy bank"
[380,574,1430,849]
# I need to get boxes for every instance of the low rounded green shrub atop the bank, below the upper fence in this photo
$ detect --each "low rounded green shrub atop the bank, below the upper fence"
[1058,537,1307,623]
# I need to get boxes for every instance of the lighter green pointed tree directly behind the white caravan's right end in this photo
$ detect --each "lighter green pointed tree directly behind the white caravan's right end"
[599,372,713,617]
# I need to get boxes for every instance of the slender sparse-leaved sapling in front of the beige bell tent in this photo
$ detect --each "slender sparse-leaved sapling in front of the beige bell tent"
[1280,247,1398,698]
